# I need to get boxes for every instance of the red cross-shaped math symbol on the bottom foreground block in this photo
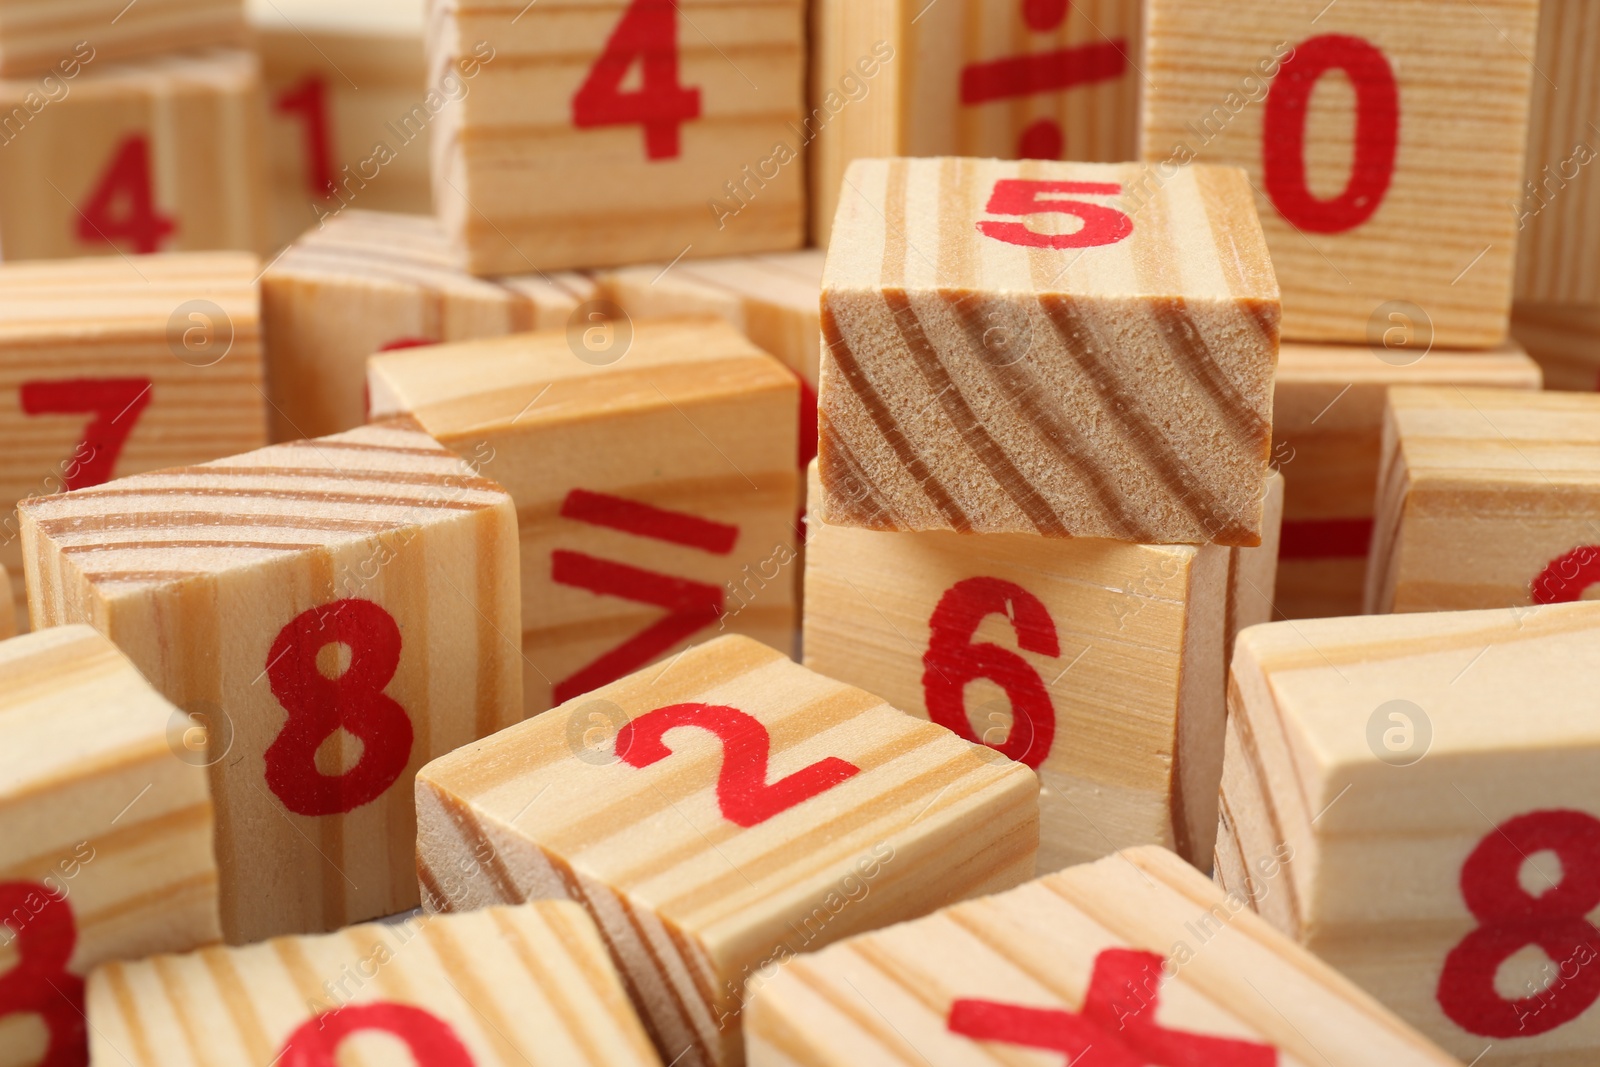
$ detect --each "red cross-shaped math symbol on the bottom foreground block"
[949,949,1278,1067]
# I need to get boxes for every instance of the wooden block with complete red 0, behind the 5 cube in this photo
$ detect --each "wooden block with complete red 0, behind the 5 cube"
[1141,0,1539,349]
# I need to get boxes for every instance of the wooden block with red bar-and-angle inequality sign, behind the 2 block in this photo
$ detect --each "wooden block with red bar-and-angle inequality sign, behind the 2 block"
[371,318,798,715]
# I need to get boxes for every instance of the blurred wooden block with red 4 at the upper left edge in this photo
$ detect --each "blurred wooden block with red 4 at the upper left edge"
[0,51,266,261]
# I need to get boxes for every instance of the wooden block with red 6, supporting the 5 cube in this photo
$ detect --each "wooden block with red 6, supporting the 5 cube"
[803,466,1228,872]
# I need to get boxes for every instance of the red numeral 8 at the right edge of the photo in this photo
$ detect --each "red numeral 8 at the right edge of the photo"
[1438,811,1600,1037]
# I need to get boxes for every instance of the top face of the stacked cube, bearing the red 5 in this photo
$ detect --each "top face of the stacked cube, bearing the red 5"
[822,158,1278,308]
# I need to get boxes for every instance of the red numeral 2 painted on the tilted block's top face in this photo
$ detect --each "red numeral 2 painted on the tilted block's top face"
[616,704,861,827]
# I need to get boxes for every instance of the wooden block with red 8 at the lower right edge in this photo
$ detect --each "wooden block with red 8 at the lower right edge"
[1216,605,1600,1067]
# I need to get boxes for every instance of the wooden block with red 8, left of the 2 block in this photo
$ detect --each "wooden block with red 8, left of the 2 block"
[21,427,522,944]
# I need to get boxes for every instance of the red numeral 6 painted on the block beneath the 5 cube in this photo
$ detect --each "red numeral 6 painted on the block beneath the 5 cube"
[922,577,1061,771]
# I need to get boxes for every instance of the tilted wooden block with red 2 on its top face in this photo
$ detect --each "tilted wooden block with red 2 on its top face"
[416,637,1038,1067]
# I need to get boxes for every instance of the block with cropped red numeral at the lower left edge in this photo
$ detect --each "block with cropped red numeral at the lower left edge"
[0,625,222,1067]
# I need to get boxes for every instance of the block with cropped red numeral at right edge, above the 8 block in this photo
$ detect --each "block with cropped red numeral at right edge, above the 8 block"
[1365,387,1600,613]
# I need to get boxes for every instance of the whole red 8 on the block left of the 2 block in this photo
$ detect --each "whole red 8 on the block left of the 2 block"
[266,600,411,816]
